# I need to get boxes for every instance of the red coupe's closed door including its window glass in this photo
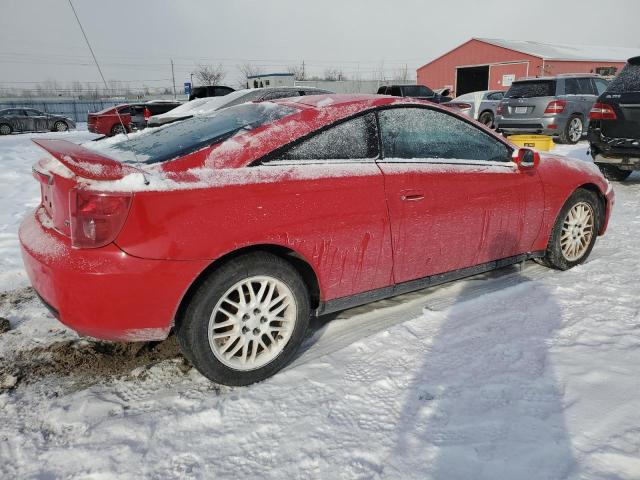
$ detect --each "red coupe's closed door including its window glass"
[378,106,544,283]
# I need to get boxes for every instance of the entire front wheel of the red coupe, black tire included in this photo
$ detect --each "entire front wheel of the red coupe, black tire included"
[539,189,602,270]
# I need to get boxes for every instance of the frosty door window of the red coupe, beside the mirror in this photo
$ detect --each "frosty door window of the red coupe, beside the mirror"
[379,107,511,162]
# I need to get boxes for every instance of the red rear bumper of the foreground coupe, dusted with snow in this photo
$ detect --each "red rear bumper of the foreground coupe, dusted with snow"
[20,209,207,341]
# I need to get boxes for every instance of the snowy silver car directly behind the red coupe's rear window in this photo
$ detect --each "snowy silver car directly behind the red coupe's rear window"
[147,87,332,127]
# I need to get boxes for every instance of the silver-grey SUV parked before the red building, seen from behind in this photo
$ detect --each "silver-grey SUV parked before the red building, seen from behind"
[495,74,608,144]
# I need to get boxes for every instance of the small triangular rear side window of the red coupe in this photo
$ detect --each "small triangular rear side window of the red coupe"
[277,113,378,160]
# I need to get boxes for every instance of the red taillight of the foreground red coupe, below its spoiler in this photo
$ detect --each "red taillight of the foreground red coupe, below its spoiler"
[69,188,132,248]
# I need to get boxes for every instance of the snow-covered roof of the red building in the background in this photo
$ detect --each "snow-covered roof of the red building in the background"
[476,38,640,62]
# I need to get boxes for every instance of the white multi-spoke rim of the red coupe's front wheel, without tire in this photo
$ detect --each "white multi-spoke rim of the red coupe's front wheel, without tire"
[560,202,595,262]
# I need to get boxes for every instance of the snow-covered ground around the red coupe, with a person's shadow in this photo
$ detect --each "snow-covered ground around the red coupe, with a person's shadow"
[0,132,640,480]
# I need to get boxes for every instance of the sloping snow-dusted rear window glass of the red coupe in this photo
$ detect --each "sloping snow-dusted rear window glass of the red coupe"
[104,102,297,164]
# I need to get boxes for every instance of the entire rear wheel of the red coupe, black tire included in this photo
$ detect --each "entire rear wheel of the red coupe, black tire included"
[176,252,310,386]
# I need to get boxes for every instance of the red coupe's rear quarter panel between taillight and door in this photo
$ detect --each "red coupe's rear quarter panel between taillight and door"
[116,162,392,300]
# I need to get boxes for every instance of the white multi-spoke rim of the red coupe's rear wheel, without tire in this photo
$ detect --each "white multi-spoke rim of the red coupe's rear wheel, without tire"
[208,276,297,371]
